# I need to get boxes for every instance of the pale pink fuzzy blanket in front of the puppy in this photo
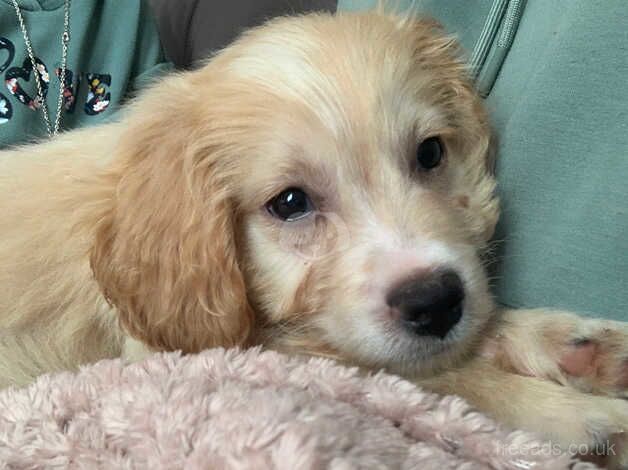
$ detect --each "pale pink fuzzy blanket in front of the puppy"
[0,349,594,470]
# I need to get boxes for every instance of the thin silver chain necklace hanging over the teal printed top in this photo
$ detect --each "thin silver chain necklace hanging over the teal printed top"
[13,0,70,137]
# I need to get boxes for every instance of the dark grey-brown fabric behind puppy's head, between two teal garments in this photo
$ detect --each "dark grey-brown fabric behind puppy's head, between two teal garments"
[151,0,337,68]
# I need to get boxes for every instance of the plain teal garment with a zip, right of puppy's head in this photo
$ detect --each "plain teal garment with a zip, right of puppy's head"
[338,0,628,320]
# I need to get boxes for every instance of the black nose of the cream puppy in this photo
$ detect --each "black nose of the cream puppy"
[386,270,464,339]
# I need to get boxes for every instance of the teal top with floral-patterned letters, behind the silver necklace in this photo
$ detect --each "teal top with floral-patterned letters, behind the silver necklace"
[0,0,169,148]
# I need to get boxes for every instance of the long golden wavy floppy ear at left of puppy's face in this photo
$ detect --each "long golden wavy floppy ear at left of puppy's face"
[91,77,253,352]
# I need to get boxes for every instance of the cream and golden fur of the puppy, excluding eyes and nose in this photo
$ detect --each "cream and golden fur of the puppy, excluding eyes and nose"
[0,7,628,462]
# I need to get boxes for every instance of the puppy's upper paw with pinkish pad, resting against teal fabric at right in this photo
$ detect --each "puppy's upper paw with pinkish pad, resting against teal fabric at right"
[485,310,628,398]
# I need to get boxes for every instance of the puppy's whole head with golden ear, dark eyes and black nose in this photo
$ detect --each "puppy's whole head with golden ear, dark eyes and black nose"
[92,13,498,371]
